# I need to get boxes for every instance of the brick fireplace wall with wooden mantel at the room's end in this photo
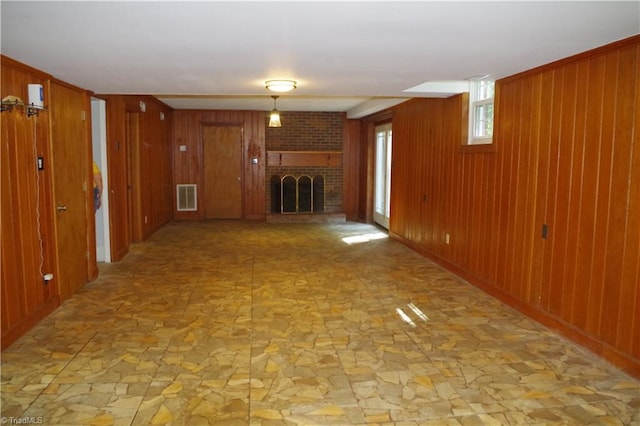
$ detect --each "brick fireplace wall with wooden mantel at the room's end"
[265,111,345,220]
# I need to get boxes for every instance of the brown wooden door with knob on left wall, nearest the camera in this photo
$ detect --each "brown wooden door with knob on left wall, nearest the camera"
[49,83,93,300]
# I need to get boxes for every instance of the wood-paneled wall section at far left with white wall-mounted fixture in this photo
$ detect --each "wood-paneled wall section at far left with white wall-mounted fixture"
[0,56,60,348]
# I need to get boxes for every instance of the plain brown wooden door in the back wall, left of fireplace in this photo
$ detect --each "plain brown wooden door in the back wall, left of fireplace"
[203,126,242,219]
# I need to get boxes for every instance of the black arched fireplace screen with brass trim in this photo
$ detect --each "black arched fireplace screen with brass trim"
[271,175,324,213]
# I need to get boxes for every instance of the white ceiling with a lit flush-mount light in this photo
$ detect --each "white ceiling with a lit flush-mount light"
[0,0,640,117]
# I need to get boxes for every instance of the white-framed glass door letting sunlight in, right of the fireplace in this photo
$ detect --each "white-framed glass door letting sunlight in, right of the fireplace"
[373,123,391,229]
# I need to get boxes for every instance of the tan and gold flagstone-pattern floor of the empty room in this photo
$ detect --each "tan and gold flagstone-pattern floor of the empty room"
[1,221,640,425]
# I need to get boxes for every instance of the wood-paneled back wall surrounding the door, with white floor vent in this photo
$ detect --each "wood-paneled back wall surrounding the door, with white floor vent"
[171,110,266,219]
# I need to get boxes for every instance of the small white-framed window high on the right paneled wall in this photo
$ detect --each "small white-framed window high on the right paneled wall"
[468,80,495,145]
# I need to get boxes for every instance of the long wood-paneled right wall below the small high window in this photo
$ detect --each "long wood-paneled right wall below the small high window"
[390,37,640,376]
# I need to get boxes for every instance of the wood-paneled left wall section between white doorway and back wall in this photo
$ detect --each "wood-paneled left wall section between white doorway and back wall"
[97,95,174,255]
